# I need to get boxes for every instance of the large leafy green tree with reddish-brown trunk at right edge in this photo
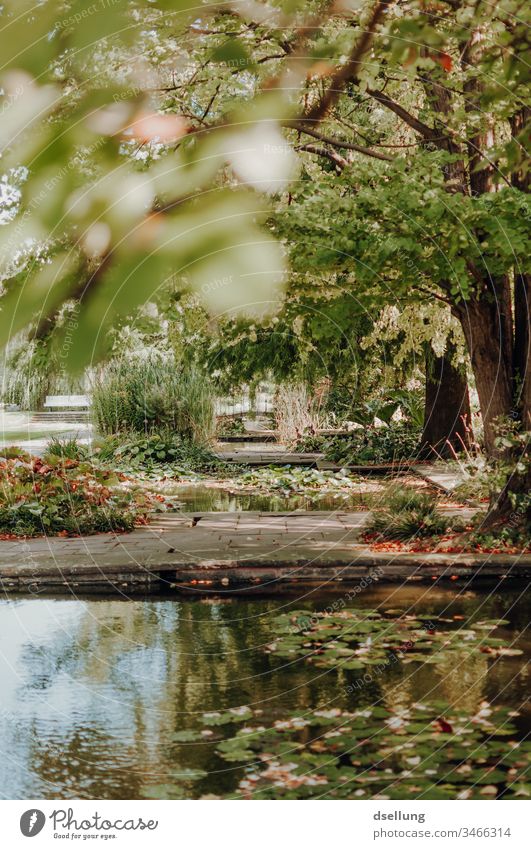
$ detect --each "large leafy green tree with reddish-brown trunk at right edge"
[276,2,531,513]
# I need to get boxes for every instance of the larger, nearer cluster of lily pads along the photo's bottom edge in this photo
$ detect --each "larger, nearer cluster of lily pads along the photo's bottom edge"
[196,701,531,799]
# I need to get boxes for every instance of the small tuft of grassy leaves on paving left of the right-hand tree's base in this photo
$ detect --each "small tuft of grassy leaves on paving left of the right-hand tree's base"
[366,487,455,540]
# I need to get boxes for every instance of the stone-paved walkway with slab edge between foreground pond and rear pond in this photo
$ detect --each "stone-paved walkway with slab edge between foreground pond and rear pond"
[0,511,531,594]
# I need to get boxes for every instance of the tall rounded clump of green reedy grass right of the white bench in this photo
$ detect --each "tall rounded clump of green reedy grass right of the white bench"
[92,353,215,444]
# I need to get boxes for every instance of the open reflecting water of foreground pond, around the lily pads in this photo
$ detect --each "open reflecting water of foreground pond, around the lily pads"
[0,586,531,799]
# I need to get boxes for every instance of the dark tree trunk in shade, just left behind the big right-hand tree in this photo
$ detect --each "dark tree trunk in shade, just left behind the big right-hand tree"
[420,346,471,457]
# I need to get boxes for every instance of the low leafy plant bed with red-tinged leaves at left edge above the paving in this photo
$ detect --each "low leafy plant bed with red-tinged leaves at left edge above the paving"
[0,454,164,536]
